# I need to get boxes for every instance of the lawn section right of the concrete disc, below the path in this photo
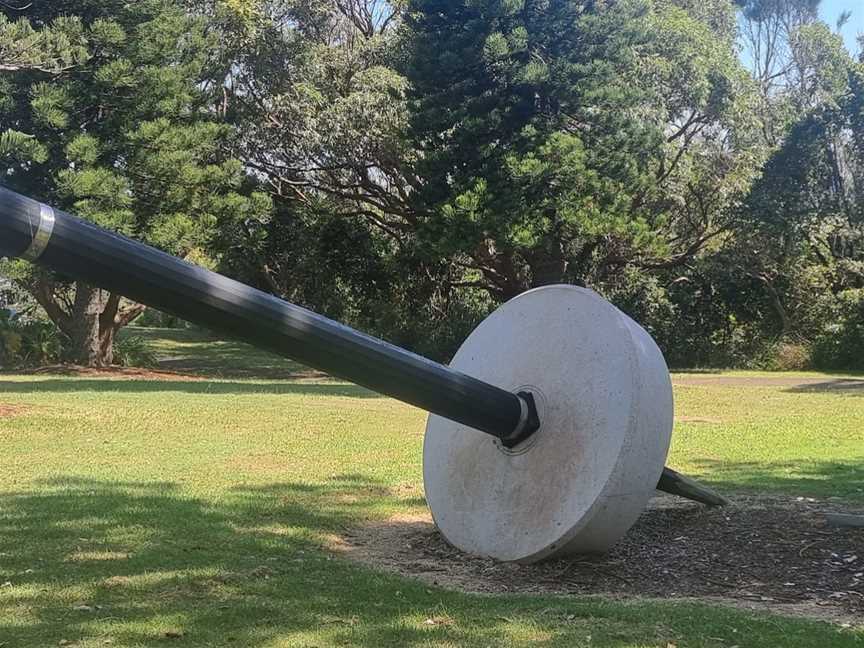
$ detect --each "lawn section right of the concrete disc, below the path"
[669,374,864,501]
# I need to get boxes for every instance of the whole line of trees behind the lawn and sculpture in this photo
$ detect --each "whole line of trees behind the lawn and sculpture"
[0,0,864,368]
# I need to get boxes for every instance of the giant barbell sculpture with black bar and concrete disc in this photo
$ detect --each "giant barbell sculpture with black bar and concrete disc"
[0,187,724,562]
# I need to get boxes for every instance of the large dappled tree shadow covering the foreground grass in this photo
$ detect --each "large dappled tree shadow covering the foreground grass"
[0,474,856,648]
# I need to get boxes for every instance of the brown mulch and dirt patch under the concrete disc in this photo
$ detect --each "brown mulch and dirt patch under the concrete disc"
[333,496,864,625]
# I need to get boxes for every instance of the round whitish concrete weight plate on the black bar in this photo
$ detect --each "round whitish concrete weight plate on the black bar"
[423,285,673,563]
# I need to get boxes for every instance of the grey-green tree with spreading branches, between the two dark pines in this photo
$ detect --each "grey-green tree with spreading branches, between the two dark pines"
[211,0,466,357]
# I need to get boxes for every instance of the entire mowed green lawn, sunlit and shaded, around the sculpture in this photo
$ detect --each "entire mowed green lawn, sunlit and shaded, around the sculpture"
[0,330,864,648]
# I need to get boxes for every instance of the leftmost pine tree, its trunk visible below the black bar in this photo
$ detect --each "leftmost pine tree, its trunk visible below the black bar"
[0,0,269,366]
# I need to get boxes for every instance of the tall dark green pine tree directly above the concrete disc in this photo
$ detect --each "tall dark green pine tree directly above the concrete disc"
[408,0,660,298]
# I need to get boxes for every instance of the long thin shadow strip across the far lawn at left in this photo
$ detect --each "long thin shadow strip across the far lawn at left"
[0,378,382,398]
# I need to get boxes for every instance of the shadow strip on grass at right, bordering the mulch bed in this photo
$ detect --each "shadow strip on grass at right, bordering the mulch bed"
[680,458,864,502]
